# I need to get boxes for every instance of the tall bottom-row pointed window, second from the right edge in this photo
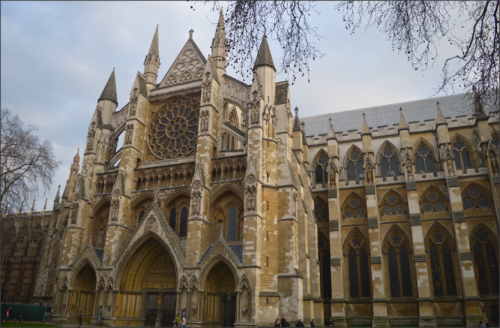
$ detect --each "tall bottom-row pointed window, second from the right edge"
[427,228,457,296]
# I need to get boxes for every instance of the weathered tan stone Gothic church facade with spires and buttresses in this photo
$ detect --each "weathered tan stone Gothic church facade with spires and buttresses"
[2,10,499,326]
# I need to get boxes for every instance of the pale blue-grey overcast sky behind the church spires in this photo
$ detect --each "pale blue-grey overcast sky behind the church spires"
[1,1,462,210]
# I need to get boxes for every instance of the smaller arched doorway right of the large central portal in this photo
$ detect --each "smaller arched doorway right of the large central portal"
[202,262,236,327]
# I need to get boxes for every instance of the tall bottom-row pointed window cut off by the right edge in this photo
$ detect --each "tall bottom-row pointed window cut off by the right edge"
[471,227,499,295]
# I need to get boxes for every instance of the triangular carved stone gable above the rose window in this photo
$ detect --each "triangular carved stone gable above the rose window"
[159,39,207,88]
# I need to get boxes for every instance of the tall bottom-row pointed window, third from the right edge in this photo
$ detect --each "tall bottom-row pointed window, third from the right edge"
[387,231,413,297]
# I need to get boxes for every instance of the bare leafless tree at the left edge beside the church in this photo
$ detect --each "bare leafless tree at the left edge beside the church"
[0,109,61,213]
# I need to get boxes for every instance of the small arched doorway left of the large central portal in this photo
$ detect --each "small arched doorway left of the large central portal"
[69,263,96,317]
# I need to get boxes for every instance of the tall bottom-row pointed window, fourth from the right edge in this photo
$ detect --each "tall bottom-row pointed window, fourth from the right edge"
[347,233,371,297]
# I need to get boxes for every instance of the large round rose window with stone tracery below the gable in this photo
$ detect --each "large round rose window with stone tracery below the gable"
[149,98,200,159]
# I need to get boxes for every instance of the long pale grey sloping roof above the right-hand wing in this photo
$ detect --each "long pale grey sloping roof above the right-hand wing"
[302,93,493,136]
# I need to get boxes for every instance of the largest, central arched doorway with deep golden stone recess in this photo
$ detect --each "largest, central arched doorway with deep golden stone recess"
[115,238,177,327]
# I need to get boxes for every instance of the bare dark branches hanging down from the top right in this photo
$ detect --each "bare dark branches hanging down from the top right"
[191,0,500,108]
